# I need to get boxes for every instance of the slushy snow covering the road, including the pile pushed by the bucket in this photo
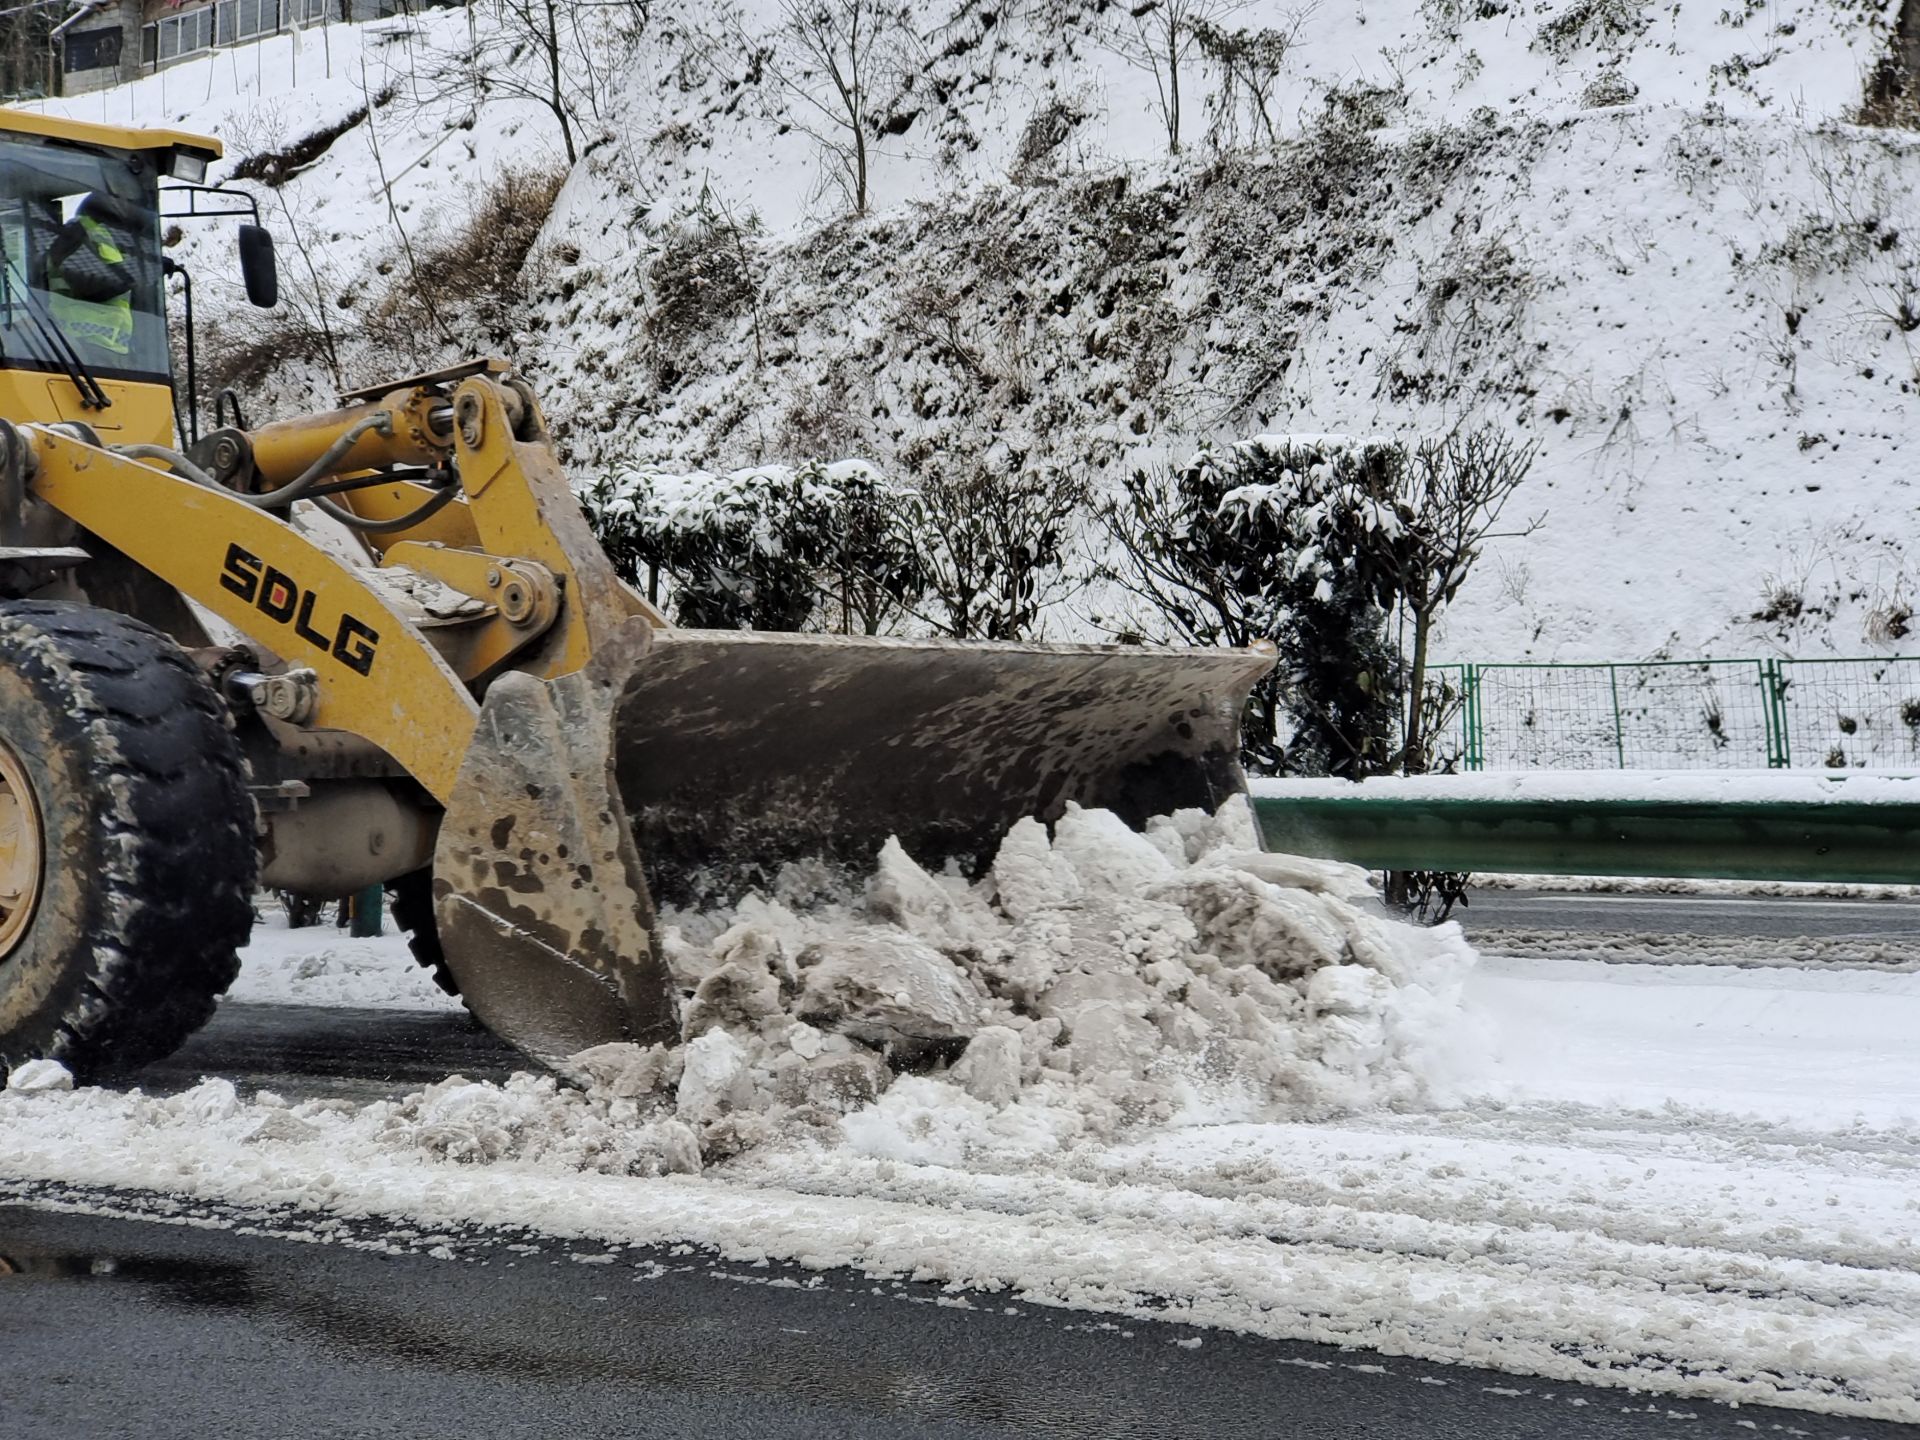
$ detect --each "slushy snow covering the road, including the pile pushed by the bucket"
[0,814,1920,1421]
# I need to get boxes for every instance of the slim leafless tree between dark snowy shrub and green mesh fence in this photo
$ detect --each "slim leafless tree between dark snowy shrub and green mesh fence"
[1380,424,1542,774]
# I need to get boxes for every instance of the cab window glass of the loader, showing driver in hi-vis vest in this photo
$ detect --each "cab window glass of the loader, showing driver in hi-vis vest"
[0,134,171,384]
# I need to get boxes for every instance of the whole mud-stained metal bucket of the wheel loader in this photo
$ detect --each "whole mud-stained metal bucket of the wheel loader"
[436,626,1273,1062]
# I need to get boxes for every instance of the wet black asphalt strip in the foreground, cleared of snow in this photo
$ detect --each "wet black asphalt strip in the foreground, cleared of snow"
[0,1192,1912,1440]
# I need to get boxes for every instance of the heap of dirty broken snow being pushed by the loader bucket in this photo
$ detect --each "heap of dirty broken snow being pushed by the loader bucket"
[468,803,1471,1171]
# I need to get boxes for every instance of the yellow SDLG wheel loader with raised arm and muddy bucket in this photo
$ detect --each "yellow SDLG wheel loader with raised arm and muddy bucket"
[0,111,1271,1077]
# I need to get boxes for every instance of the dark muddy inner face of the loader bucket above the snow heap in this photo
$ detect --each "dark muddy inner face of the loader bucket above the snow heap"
[612,630,1273,904]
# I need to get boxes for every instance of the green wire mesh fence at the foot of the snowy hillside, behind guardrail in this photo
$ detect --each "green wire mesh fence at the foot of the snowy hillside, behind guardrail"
[1432,657,1920,770]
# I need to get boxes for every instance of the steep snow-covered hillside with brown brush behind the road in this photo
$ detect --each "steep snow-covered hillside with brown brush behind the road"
[26,0,1920,659]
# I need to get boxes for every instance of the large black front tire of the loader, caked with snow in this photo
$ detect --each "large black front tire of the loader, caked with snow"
[0,601,259,1079]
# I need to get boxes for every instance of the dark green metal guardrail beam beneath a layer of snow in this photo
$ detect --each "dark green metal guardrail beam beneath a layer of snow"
[1254,795,1920,885]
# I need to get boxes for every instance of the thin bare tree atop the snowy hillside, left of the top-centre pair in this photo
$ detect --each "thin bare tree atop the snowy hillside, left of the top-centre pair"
[762,0,912,215]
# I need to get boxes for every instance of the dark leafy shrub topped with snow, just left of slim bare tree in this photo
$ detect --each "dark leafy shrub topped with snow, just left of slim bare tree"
[1102,436,1405,778]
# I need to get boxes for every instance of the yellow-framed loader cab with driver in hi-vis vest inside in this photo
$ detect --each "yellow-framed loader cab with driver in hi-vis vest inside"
[0,109,249,445]
